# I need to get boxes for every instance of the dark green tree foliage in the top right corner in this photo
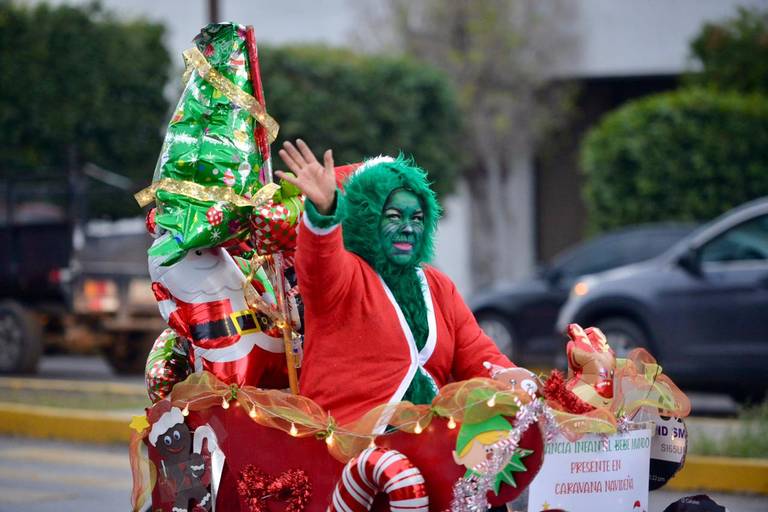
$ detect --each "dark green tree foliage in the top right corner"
[689,7,768,93]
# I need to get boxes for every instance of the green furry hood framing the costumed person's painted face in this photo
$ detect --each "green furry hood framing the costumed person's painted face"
[342,155,442,273]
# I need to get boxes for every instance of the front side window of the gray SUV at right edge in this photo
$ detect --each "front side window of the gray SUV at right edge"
[701,215,768,263]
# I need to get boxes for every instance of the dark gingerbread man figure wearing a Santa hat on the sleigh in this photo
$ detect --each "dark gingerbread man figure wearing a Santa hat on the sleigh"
[149,401,213,512]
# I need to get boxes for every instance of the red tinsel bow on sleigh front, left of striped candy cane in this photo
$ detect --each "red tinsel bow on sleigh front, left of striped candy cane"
[237,464,312,512]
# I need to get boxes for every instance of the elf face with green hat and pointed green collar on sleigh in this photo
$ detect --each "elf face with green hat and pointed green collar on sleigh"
[453,415,533,495]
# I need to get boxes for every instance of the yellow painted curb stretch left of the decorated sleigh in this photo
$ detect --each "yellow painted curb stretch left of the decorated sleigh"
[0,403,131,444]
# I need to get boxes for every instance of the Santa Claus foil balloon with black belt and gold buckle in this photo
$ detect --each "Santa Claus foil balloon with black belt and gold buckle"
[149,234,287,388]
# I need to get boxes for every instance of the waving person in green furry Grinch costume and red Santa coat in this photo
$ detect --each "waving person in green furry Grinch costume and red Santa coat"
[276,140,535,424]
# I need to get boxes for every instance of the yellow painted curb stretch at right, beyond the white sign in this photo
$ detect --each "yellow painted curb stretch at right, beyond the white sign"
[664,455,768,494]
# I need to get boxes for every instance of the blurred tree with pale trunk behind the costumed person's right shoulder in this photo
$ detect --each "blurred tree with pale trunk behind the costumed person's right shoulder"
[352,0,576,286]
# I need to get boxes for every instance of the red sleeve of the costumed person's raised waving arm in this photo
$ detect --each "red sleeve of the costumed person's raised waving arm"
[296,217,358,307]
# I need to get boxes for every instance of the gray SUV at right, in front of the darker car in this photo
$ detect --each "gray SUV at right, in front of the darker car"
[557,197,768,399]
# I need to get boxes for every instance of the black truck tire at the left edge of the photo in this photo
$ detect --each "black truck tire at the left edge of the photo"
[0,300,43,373]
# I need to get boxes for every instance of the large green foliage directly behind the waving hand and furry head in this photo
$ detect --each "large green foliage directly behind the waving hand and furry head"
[259,46,462,197]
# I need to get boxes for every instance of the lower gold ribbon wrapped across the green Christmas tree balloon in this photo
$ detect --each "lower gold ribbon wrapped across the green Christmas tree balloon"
[133,178,280,207]
